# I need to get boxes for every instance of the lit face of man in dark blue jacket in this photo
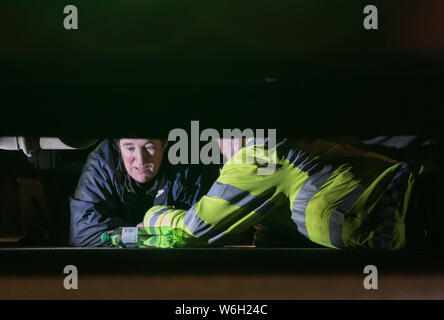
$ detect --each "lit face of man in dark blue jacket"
[119,138,167,183]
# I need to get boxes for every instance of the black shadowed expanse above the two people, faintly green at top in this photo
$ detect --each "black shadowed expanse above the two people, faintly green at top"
[0,0,444,137]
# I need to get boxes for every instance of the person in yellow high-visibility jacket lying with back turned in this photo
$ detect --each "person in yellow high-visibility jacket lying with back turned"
[143,139,422,250]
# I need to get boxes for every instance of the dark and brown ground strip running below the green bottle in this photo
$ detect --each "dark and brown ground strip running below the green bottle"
[0,248,444,300]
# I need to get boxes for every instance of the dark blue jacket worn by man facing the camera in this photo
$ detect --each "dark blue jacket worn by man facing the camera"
[69,140,219,247]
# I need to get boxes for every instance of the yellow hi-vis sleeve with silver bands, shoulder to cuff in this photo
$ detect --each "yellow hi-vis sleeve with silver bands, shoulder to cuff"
[140,139,286,247]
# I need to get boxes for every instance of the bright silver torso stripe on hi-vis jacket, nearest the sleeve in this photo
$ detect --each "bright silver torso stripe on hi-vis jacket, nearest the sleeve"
[291,165,334,239]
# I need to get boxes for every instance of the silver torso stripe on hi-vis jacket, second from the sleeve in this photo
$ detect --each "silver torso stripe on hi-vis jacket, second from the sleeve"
[328,184,367,248]
